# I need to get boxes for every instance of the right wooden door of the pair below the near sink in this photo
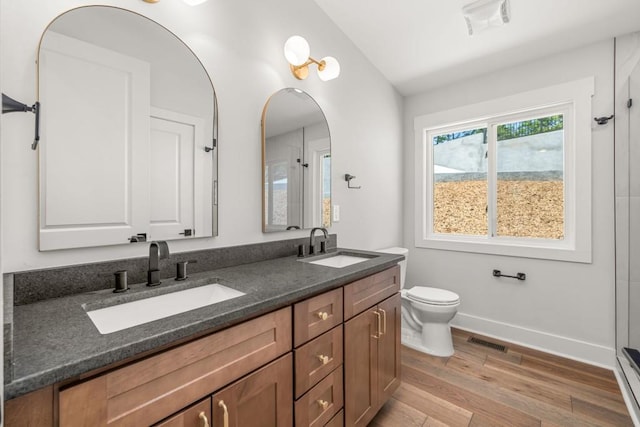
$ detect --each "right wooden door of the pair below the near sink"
[213,353,293,427]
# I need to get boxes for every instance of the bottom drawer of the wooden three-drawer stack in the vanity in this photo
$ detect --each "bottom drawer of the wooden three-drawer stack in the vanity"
[295,366,343,427]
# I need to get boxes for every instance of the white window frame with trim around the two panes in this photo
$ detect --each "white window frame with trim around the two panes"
[414,77,594,263]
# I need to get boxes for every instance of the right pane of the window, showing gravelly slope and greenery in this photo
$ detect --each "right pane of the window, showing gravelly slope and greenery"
[496,115,564,239]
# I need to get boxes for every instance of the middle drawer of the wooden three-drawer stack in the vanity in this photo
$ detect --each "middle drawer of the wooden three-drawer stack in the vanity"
[295,325,342,399]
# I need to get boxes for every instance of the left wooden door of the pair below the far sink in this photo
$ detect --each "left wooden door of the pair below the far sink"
[344,307,380,426]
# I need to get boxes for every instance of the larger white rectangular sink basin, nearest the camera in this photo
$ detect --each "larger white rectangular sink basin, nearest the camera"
[87,283,244,334]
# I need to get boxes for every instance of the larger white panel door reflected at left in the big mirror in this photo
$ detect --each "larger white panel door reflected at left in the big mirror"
[39,32,150,250]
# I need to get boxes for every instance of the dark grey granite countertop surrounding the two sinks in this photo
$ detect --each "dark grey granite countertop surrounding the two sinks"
[4,249,404,400]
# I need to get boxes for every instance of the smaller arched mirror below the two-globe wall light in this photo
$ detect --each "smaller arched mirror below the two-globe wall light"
[262,88,331,233]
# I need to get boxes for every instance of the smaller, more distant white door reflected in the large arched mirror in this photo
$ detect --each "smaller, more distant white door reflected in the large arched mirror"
[150,108,206,240]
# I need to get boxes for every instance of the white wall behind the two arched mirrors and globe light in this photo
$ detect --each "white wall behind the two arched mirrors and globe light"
[0,0,402,272]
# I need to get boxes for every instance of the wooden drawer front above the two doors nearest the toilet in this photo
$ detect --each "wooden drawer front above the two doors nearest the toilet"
[344,265,400,320]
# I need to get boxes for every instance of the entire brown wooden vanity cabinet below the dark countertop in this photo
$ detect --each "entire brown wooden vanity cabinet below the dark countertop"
[5,266,401,427]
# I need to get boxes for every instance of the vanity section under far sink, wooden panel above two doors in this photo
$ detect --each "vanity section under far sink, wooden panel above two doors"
[344,267,401,426]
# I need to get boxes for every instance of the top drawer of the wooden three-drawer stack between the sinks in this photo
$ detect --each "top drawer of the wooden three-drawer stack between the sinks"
[293,288,342,347]
